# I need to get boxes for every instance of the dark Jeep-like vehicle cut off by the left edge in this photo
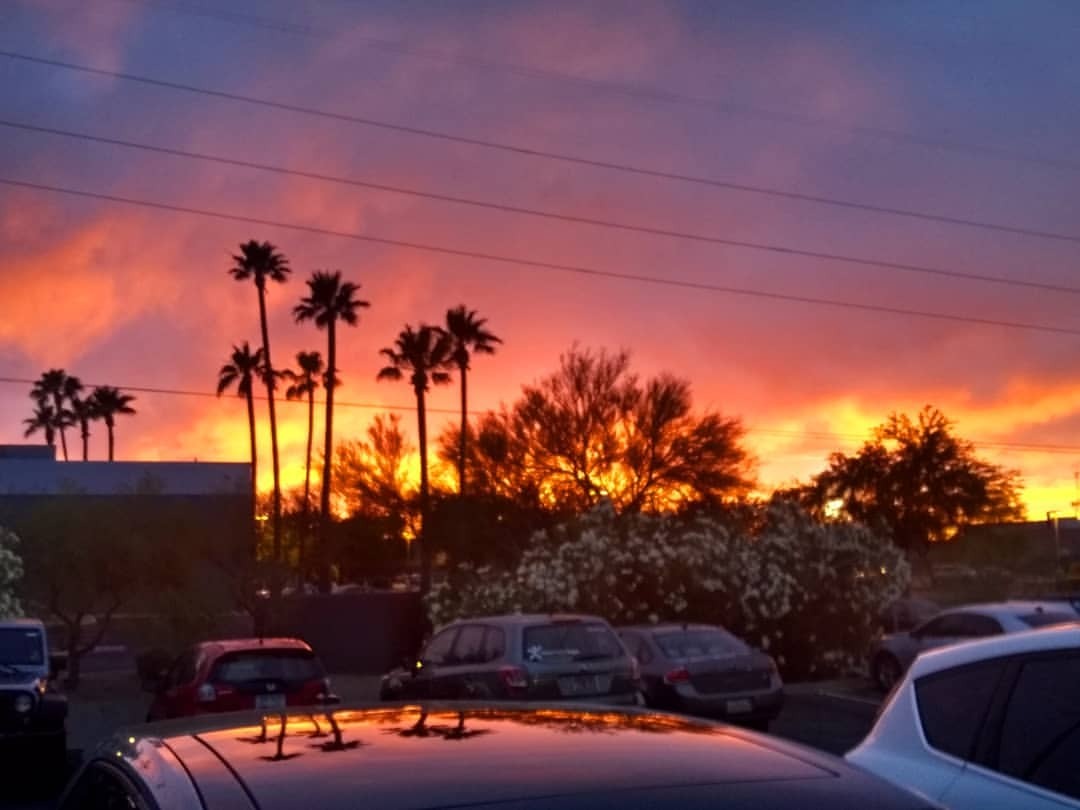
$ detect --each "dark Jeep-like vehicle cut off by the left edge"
[0,619,68,768]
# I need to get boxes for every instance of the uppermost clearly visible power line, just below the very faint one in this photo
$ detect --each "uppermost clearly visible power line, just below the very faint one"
[8,50,1080,242]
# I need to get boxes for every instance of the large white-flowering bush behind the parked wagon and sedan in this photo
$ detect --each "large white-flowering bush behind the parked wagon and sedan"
[428,502,909,676]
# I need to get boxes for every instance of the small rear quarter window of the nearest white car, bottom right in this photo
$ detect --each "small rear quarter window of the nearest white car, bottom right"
[915,661,1004,759]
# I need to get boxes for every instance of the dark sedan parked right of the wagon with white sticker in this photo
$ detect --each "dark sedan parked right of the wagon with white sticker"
[619,624,784,731]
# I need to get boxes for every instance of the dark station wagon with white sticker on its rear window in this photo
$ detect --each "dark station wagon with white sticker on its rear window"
[380,615,639,704]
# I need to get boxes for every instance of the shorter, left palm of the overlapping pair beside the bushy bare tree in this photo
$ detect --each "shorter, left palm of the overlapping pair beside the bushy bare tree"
[377,324,453,595]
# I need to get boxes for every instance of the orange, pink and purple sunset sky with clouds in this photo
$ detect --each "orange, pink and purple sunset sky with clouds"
[0,0,1080,518]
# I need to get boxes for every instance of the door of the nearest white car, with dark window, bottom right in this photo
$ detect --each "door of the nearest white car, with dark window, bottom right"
[942,650,1080,810]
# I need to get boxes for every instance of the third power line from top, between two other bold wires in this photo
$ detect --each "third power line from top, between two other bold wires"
[0,119,1080,295]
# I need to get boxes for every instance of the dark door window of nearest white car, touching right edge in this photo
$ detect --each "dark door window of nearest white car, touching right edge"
[997,656,1080,798]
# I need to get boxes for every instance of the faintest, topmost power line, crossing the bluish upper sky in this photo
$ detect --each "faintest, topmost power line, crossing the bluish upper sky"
[109,0,1080,171]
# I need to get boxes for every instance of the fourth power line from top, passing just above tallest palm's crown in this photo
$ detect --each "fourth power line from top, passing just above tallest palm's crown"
[0,177,1080,337]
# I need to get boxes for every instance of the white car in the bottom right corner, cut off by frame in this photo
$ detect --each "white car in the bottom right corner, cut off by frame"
[846,623,1080,810]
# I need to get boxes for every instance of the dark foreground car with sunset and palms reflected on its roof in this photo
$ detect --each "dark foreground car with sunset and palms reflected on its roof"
[60,703,933,810]
